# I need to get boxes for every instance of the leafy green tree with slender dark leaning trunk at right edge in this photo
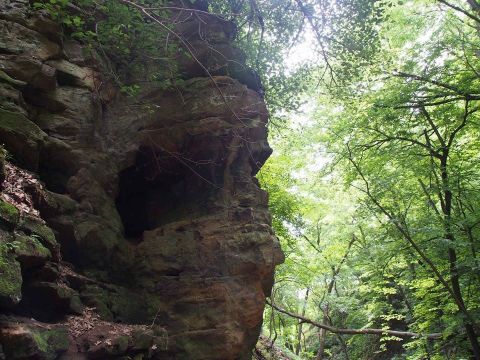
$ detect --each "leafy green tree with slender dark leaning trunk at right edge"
[320,2,480,358]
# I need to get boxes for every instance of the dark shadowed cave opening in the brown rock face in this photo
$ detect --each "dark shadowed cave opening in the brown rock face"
[115,148,219,242]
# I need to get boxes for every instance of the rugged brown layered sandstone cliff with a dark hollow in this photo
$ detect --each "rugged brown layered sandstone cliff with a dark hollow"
[0,0,283,360]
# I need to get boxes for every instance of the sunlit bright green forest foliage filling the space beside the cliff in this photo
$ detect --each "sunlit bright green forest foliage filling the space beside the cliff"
[249,0,480,359]
